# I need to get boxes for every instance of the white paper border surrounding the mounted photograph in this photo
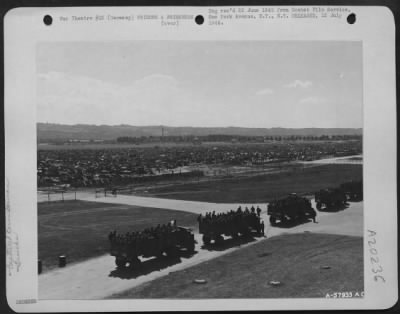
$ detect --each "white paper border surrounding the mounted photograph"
[4,6,398,312]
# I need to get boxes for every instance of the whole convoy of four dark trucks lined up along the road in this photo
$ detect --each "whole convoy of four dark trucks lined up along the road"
[109,181,363,268]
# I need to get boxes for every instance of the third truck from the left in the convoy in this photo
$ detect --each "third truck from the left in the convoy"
[267,193,317,226]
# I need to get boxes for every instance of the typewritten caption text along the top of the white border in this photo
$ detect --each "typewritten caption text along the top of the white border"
[58,7,351,27]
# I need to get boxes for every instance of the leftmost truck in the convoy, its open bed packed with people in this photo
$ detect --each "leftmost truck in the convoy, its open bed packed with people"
[109,223,195,268]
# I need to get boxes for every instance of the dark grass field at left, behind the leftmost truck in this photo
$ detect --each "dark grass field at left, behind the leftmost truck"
[38,201,197,271]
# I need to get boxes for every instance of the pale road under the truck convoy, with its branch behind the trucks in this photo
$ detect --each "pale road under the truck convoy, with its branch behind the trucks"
[39,193,363,300]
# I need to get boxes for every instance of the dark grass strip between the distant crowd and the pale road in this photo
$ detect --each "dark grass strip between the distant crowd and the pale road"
[146,164,362,203]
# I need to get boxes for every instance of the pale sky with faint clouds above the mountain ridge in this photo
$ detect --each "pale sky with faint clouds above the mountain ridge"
[37,41,362,128]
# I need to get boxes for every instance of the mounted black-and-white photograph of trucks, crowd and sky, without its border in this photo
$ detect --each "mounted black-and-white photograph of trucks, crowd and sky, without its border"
[37,41,364,299]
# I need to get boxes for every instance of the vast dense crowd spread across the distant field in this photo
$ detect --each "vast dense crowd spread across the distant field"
[37,141,362,187]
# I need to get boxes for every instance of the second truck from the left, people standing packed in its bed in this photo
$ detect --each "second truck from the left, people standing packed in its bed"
[198,208,262,245]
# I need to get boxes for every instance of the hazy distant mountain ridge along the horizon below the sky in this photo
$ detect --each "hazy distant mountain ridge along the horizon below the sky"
[37,123,362,141]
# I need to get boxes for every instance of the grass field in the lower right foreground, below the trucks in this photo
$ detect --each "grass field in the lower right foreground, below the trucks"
[110,233,364,298]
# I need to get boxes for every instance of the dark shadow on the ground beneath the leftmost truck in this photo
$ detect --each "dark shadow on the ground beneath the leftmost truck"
[108,251,197,279]
